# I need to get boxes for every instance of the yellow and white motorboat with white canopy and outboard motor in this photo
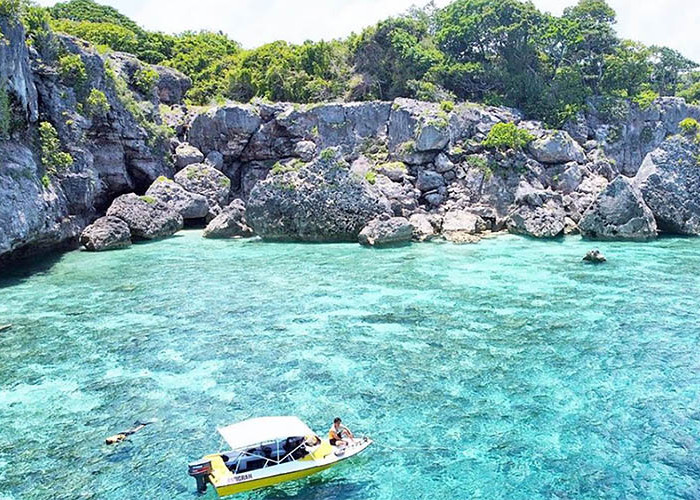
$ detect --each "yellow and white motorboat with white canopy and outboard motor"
[189,417,372,496]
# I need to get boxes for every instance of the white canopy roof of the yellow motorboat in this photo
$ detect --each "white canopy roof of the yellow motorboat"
[217,417,314,450]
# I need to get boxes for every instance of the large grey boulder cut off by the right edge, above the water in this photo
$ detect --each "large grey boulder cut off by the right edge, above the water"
[633,136,700,235]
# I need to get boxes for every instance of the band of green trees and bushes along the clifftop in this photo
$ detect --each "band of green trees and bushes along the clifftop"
[9,0,700,125]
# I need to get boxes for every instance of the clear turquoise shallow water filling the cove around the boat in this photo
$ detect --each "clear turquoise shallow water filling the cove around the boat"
[0,231,700,500]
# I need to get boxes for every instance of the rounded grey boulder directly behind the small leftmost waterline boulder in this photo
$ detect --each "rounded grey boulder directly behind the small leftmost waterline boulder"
[107,193,183,240]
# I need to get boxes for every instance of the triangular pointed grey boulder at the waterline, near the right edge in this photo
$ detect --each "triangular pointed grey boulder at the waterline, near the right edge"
[578,176,657,240]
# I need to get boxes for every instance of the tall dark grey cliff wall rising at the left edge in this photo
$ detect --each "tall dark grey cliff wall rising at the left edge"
[0,16,188,261]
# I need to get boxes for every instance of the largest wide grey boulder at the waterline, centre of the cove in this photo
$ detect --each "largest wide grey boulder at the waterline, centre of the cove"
[246,152,390,241]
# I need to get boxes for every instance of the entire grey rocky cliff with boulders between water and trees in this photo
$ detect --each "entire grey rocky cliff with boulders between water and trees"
[0,10,700,259]
